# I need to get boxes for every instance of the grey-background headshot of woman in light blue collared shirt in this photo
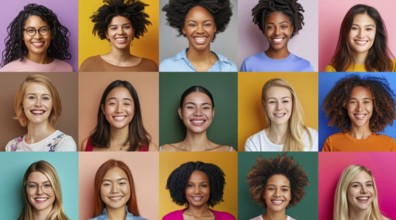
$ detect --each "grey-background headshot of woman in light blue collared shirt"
[160,0,238,72]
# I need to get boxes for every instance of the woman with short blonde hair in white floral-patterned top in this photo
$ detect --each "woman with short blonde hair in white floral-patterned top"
[5,74,77,152]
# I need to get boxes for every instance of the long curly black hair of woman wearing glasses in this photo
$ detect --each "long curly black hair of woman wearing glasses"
[1,4,71,66]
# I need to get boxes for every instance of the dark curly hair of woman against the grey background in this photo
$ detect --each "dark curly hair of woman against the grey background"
[162,0,232,40]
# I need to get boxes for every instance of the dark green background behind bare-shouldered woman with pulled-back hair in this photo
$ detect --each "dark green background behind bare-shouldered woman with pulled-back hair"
[159,73,238,150]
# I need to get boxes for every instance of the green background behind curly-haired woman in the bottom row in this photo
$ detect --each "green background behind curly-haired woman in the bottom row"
[238,152,318,220]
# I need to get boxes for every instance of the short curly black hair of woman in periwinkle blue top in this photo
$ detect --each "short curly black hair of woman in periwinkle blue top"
[252,0,304,38]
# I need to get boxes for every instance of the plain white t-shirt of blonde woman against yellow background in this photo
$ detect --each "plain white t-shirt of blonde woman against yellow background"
[245,128,318,151]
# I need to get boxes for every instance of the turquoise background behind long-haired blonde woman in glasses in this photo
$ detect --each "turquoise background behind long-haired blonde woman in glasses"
[0,152,78,219]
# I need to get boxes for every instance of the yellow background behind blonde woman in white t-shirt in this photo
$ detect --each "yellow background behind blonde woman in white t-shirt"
[238,72,318,151]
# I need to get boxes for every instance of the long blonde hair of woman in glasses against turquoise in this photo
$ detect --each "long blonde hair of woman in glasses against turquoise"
[18,160,68,220]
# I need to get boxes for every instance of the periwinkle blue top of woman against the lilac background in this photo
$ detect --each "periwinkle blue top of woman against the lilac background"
[241,52,314,72]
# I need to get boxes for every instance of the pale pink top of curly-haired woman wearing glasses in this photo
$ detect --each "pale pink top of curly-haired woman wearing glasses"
[0,57,73,72]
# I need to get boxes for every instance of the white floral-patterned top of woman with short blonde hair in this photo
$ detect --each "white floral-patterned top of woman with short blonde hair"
[5,130,77,152]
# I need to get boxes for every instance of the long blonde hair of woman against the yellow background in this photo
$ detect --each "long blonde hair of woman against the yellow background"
[261,78,313,151]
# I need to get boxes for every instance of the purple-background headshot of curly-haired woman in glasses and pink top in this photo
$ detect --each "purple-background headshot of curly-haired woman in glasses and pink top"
[0,0,77,72]
